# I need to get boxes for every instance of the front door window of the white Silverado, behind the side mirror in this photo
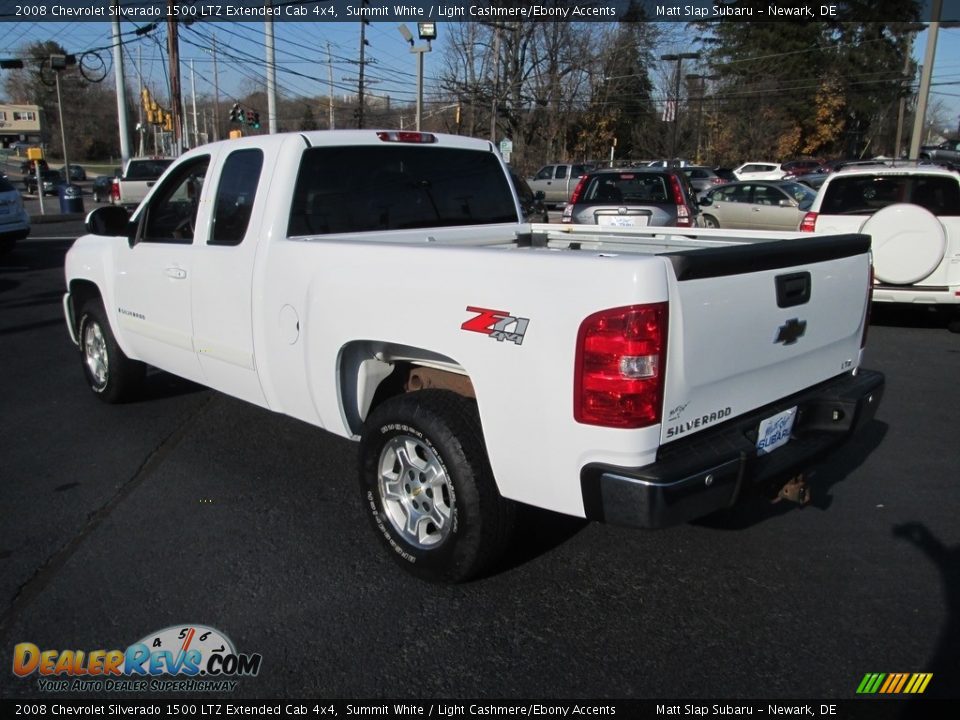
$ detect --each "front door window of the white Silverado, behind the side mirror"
[140,155,210,245]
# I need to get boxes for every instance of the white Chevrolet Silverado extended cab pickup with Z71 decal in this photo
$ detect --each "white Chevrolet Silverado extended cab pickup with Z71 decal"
[63,130,883,581]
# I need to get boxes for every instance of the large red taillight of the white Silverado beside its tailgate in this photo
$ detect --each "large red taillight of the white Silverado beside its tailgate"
[573,302,667,428]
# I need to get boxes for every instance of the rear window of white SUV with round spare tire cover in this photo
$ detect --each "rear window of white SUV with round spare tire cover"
[820,175,960,216]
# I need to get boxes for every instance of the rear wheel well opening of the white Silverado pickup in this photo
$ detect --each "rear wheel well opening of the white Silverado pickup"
[338,341,475,435]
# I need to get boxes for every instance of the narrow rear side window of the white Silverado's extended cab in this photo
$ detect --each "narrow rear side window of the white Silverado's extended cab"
[207,149,263,245]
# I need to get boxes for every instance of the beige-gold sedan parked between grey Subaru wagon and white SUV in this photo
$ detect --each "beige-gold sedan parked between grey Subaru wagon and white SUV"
[700,180,816,230]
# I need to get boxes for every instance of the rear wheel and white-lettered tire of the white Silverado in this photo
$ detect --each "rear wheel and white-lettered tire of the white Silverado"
[360,390,516,583]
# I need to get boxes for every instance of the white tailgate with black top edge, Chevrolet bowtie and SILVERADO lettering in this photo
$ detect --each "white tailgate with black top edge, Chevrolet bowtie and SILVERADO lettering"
[661,235,870,443]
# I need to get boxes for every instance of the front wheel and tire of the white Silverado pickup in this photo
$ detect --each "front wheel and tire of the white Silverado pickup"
[77,301,146,403]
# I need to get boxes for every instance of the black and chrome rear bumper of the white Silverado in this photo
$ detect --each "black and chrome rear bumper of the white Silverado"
[580,370,884,528]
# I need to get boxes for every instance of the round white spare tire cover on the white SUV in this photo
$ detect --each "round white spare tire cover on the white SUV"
[860,203,947,285]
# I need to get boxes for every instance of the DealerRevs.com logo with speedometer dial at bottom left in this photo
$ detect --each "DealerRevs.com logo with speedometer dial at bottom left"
[13,624,263,692]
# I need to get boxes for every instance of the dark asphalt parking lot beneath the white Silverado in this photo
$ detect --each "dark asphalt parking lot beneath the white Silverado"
[0,232,960,699]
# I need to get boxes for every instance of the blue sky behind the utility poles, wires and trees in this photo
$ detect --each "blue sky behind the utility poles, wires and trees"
[0,20,960,133]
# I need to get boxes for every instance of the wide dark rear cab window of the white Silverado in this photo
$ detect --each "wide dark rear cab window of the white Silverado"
[287,145,518,236]
